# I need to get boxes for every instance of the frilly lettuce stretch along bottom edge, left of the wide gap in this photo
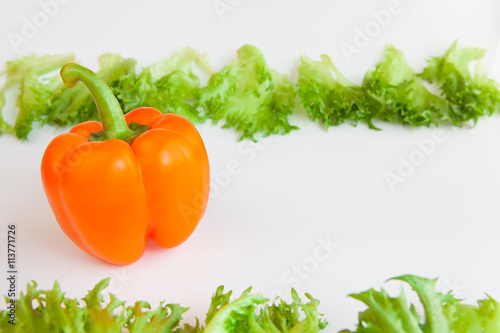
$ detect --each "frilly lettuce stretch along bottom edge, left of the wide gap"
[0,278,327,333]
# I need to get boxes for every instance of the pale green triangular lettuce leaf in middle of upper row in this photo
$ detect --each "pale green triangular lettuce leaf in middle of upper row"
[200,45,298,141]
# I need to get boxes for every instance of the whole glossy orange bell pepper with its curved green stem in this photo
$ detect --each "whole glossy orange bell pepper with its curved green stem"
[41,64,210,265]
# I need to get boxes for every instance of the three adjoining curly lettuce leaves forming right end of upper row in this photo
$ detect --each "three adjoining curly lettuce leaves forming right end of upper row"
[297,42,500,129]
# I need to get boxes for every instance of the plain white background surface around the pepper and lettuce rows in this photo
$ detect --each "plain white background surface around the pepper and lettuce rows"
[0,0,500,332]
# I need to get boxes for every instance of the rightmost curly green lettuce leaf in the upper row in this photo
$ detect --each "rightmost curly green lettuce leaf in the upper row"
[419,42,500,126]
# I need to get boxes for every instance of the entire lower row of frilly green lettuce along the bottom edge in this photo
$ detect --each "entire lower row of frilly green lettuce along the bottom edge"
[0,275,500,333]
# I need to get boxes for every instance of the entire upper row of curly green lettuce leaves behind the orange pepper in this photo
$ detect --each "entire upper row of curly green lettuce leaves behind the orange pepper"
[0,42,500,140]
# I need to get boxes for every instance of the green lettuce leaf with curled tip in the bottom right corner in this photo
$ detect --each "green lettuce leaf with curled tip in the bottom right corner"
[342,275,500,333]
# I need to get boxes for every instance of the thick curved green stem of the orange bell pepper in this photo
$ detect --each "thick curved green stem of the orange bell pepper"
[61,63,137,141]
